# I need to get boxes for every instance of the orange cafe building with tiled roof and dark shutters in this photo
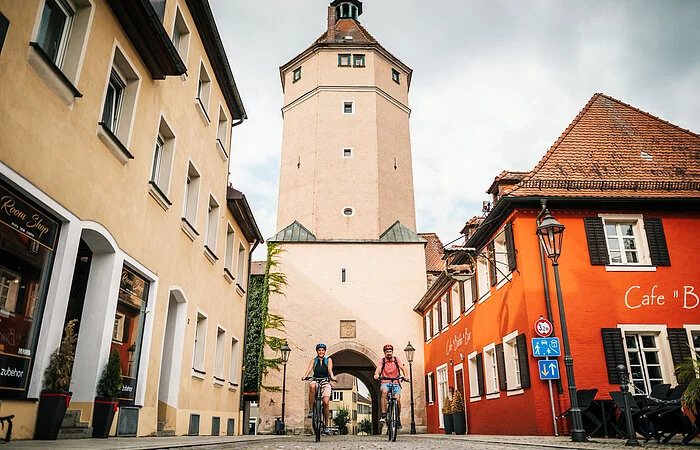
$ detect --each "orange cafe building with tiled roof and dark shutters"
[415,94,700,435]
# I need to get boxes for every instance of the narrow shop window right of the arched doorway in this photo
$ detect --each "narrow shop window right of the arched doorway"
[110,266,150,406]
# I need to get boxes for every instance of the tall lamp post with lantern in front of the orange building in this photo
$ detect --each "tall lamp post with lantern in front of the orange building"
[537,210,587,442]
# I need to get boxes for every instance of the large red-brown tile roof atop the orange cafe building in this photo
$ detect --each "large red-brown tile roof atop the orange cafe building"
[503,94,700,198]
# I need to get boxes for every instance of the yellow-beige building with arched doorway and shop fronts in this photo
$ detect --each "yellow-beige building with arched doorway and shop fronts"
[0,0,262,439]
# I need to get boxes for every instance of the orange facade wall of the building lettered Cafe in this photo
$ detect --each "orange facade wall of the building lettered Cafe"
[425,210,700,435]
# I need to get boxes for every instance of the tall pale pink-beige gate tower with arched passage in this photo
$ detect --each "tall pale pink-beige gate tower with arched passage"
[260,0,426,432]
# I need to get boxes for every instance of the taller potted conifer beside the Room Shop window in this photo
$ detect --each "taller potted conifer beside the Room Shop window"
[34,319,78,440]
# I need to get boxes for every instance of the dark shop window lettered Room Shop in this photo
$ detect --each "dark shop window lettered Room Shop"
[0,183,60,399]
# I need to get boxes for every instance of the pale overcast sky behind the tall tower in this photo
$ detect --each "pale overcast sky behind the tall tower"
[210,0,700,259]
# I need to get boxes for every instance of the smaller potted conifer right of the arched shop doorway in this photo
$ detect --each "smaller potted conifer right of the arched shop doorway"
[92,350,123,438]
